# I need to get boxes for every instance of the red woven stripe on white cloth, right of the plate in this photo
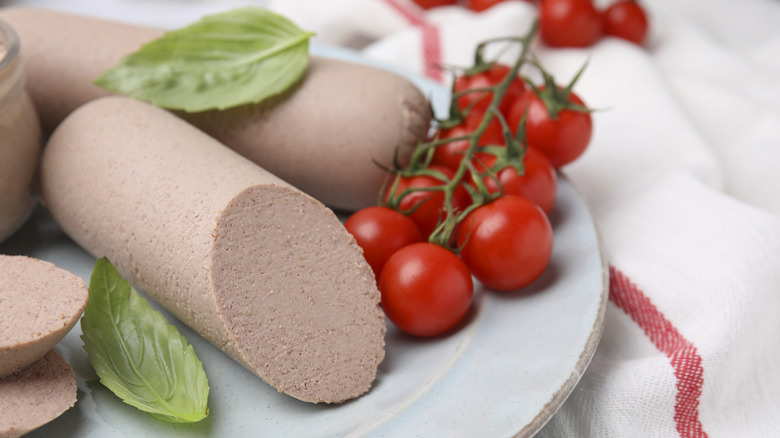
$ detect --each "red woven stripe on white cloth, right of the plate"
[609,266,707,438]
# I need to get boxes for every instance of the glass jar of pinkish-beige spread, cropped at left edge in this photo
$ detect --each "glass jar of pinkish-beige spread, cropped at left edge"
[0,20,42,242]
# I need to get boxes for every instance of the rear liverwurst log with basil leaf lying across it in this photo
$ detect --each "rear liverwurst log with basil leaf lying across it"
[0,8,431,210]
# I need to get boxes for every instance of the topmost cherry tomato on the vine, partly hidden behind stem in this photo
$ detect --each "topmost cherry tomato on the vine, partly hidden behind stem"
[454,64,525,114]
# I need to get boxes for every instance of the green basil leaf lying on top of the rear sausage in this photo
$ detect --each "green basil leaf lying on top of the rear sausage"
[95,7,312,112]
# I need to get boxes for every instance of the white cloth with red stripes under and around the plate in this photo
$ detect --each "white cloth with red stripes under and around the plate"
[6,0,780,438]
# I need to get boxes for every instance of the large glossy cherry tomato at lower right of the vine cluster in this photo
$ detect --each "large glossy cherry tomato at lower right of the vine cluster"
[458,195,553,291]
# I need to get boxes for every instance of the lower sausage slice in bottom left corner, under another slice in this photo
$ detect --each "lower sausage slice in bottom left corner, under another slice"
[0,350,76,437]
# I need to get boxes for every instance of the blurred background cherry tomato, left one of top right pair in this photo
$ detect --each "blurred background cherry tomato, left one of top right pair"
[539,0,601,47]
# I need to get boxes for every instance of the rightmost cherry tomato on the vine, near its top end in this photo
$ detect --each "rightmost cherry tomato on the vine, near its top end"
[508,86,593,168]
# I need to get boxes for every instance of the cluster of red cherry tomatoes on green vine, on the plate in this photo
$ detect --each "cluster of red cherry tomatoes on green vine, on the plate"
[345,18,590,336]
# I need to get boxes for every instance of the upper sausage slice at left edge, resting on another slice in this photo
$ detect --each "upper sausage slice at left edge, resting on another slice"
[0,255,89,378]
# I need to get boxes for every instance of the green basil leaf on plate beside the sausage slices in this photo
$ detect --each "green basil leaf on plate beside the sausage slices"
[81,258,209,423]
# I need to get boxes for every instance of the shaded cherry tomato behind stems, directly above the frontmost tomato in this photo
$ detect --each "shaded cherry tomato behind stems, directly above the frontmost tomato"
[385,166,471,239]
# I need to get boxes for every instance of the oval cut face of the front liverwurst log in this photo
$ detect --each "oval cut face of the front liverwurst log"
[213,186,385,403]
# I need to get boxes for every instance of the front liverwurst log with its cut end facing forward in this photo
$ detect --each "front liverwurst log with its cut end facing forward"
[40,96,385,402]
